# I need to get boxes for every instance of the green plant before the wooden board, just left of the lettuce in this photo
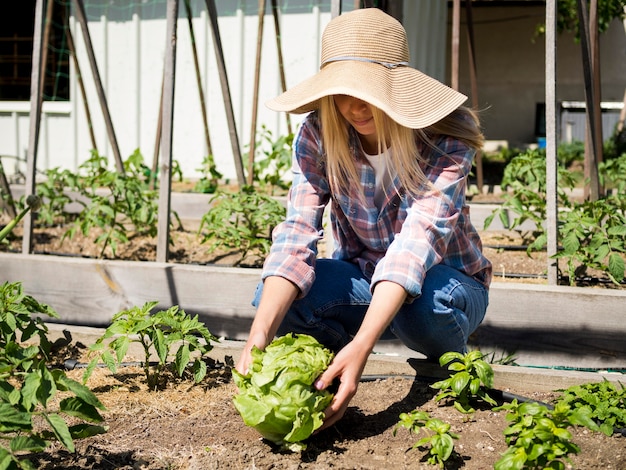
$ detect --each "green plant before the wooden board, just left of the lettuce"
[83,302,219,390]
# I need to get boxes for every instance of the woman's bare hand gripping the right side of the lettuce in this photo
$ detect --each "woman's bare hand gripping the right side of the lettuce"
[315,341,370,431]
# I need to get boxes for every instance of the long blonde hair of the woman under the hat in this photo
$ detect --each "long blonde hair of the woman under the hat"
[319,96,484,196]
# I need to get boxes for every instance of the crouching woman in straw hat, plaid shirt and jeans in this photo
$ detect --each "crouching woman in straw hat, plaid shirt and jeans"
[237,8,491,427]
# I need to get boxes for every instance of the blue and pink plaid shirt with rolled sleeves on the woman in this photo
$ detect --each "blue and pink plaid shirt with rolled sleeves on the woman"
[263,112,491,297]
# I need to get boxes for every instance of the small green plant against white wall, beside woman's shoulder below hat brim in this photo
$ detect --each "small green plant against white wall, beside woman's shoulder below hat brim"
[254,126,294,195]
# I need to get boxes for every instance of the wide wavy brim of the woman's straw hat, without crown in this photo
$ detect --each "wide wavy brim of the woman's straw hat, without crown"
[265,61,467,129]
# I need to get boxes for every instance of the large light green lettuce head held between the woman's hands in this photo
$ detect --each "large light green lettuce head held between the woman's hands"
[232,333,333,451]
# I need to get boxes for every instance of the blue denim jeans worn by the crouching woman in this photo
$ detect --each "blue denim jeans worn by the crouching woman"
[252,259,489,360]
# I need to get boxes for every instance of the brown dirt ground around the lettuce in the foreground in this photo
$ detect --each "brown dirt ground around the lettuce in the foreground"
[20,332,626,470]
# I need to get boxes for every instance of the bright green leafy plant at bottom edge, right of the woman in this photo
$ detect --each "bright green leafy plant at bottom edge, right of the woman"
[494,400,597,470]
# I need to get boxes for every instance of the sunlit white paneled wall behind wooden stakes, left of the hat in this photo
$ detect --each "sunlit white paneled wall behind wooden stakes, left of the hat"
[0,0,345,179]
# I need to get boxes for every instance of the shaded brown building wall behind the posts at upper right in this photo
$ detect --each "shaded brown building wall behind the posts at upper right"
[450,6,626,146]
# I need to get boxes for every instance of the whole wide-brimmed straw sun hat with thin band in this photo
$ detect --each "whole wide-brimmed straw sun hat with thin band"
[266,8,467,129]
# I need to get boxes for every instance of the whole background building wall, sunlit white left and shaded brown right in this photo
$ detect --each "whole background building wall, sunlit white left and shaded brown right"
[0,0,626,179]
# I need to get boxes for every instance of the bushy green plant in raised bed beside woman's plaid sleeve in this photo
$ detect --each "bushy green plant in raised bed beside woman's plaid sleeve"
[198,187,286,265]
